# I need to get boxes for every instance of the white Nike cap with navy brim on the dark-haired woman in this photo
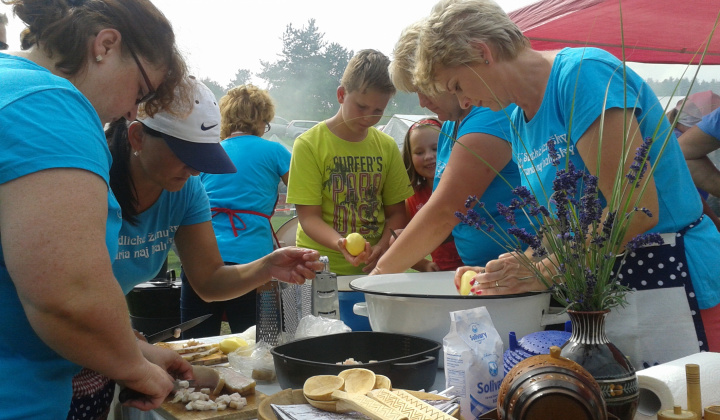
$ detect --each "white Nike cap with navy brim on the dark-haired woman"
[137,77,237,174]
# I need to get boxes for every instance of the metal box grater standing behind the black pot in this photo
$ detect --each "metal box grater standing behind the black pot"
[256,279,312,346]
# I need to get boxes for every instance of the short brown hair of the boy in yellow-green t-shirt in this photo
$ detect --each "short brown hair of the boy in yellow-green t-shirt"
[340,49,395,95]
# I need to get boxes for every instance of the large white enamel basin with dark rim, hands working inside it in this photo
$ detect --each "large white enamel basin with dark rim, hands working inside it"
[350,271,551,349]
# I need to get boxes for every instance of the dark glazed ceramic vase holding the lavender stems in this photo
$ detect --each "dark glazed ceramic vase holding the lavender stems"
[560,310,640,420]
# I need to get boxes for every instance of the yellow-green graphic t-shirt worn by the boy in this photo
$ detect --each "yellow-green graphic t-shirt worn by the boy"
[287,122,413,275]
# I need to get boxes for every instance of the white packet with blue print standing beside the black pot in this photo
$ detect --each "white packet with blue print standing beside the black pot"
[443,306,504,420]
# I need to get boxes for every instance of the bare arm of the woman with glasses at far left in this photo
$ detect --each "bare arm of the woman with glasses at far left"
[0,169,172,404]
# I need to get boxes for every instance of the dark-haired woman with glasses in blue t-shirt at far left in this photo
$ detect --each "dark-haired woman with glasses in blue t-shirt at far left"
[0,0,192,419]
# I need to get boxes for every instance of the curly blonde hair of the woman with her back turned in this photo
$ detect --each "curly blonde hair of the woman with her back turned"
[220,84,275,140]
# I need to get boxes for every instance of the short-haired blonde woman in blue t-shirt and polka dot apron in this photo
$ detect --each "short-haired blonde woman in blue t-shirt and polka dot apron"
[415,0,720,367]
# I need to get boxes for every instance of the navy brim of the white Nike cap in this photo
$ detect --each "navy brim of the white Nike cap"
[163,134,237,174]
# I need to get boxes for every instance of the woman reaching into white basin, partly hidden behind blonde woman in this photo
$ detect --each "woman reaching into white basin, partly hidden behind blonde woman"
[371,22,529,274]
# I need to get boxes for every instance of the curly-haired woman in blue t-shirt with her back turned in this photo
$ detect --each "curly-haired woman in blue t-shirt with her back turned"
[180,85,290,338]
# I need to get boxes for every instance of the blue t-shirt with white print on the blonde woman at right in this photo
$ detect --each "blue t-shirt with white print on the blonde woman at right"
[512,48,720,309]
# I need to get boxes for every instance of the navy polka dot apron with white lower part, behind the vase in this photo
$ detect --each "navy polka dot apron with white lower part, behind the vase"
[606,216,708,369]
